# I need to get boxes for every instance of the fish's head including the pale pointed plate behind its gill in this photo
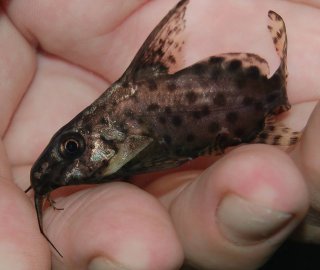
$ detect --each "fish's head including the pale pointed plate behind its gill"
[30,117,152,196]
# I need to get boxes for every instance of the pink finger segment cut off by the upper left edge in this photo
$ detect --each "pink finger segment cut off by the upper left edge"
[0,7,35,138]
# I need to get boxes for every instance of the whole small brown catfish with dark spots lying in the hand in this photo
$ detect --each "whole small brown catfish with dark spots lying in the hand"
[26,0,299,255]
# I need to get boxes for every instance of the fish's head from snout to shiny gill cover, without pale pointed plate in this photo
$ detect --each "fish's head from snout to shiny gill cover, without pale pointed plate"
[30,128,111,195]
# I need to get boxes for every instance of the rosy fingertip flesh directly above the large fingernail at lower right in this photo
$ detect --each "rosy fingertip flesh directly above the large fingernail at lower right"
[215,145,308,216]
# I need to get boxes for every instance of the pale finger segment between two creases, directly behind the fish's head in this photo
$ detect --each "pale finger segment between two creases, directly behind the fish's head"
[4,55,105,169]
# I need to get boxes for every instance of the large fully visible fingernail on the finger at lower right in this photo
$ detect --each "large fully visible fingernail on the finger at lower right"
[217,194,292,245]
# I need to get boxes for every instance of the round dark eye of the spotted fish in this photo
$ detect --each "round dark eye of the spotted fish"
[60,133,85,158]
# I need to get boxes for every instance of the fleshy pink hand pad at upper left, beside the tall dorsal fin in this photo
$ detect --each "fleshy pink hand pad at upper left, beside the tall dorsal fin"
[7,0,150,76]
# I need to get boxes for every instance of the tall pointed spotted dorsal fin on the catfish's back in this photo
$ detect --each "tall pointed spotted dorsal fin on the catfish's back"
[122,0,189,81]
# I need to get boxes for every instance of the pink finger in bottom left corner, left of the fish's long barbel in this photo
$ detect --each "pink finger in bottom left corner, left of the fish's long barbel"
[0,142,50,270]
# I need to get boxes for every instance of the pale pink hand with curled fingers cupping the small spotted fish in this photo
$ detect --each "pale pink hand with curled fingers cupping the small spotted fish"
[0,0,320,270]
